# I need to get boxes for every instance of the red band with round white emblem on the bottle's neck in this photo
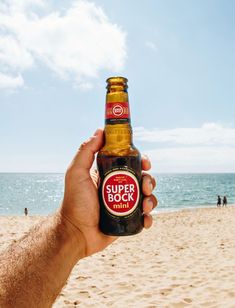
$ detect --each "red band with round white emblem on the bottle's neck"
[105,102,130,119]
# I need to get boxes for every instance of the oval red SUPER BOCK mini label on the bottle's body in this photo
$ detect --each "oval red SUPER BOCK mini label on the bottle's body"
[102,170,140,216]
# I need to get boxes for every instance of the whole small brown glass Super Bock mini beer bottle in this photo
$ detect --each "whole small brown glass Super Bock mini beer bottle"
[97,77,143,236]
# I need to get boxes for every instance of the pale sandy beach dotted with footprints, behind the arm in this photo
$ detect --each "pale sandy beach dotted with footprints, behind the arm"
[0,206,235,308]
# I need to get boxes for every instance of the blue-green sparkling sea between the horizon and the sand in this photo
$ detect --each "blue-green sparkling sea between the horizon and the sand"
[0,173,235,216]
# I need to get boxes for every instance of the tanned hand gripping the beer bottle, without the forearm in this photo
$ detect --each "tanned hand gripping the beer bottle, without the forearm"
[60,129,157,257]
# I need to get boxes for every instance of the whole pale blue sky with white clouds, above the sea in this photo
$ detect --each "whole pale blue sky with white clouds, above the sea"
[0,0,235,173]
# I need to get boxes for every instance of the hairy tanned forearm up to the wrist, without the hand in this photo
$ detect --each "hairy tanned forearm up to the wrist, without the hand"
[0,214,84,308]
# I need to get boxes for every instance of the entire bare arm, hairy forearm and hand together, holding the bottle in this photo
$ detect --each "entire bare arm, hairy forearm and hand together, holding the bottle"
[0,129,157,308]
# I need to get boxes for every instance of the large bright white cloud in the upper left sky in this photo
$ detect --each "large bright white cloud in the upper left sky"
[0,0,126,89]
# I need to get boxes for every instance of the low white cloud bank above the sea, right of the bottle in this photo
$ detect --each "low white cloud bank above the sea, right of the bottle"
[135,123,235,172]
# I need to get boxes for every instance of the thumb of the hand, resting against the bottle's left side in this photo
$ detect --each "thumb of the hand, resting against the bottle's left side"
[71,128,104,170]
